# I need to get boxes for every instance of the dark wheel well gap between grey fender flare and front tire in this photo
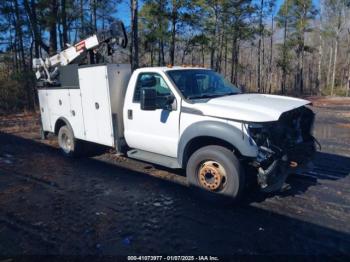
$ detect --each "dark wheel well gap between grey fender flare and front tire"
[182,136,241,167]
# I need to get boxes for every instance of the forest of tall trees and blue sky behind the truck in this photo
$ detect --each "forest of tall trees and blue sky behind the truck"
[0,0,350,113]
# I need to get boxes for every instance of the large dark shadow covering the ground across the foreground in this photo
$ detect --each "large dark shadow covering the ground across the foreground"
[0,133,350,255]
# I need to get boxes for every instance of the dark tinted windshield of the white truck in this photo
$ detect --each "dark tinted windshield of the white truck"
[167,69,241,99]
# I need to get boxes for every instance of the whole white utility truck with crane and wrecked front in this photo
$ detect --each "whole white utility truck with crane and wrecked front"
[34,21,315,199]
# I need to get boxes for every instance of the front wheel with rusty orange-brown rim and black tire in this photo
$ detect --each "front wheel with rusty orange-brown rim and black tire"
[186,145,245,202]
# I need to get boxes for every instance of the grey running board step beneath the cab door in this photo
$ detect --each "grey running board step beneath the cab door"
[127,149,181,168]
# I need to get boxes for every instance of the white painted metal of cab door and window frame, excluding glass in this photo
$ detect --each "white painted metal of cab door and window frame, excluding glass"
[123,68,181,157]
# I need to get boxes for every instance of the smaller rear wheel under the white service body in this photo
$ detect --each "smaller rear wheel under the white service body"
[58,126,79,157]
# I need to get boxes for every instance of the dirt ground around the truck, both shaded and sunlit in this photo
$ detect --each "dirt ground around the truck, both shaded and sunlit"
[0,98,350,258]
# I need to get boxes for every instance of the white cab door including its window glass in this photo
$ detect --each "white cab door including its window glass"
[124,73,180,157]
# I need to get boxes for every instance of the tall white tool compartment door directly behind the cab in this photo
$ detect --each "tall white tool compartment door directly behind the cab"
[78,66,114,146]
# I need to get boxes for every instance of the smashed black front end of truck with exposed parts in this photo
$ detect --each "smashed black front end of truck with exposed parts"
[248,107,316,192]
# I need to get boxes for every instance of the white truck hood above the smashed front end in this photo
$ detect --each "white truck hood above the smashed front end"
[185,94,310,123]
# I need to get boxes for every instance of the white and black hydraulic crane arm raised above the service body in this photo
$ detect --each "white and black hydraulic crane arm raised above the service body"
[33,21,128,84]
